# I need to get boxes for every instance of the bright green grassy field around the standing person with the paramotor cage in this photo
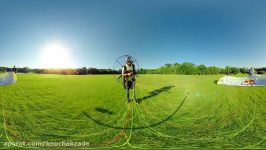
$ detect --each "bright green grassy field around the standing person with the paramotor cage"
[0,74,266,149]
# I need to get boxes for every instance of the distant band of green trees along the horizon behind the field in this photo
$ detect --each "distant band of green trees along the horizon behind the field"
[0,62,266,75]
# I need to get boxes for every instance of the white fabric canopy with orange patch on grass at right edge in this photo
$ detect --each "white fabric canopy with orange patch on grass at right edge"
[217,75,266,86]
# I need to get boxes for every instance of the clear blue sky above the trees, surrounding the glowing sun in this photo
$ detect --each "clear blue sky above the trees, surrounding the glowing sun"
[0,0,266,68]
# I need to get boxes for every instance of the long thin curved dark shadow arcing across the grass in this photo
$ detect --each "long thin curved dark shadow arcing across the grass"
[82,92,189,130]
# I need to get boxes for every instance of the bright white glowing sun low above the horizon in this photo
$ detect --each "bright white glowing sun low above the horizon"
[41,42,72,68]
